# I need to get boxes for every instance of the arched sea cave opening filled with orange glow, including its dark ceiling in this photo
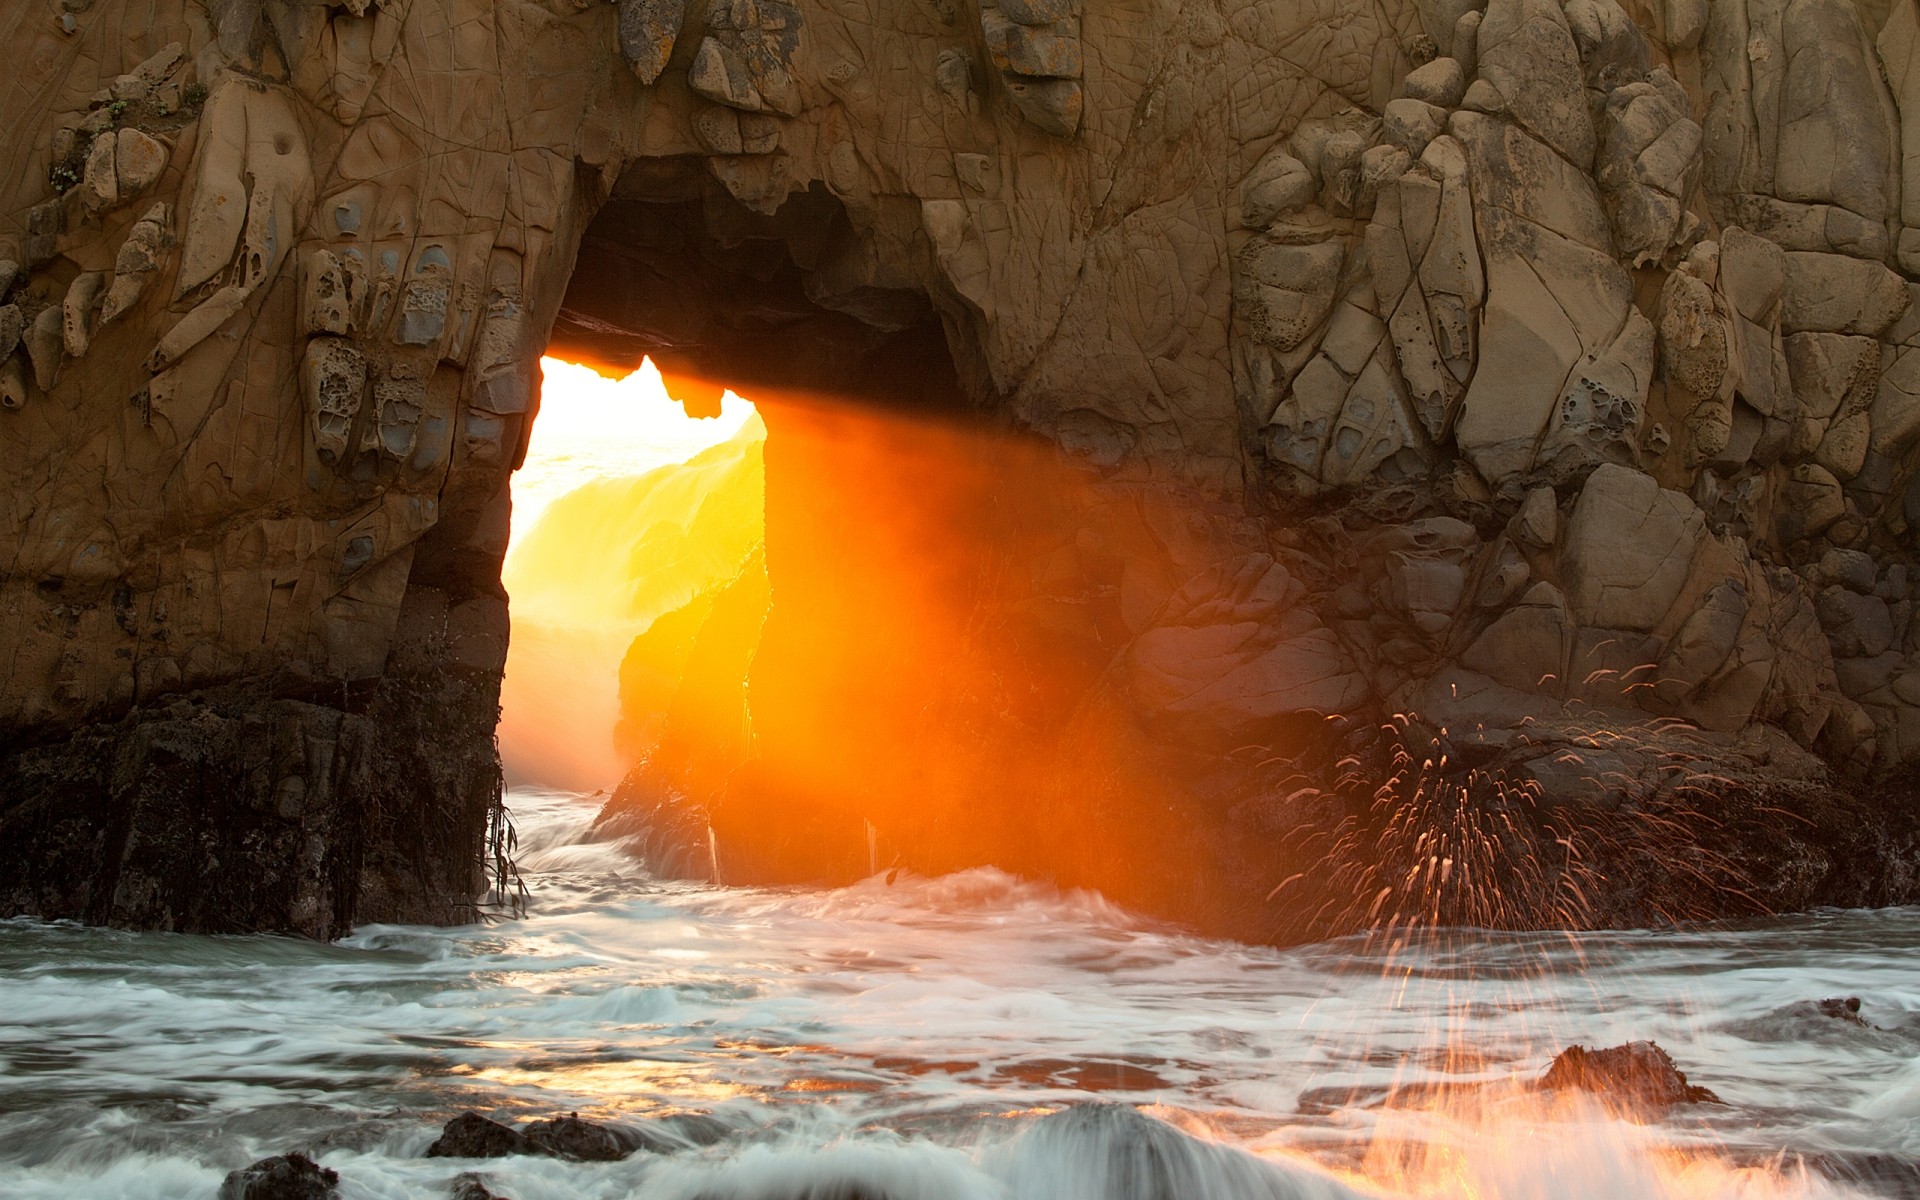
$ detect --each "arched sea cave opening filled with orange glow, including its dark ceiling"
[499,159,1246,914]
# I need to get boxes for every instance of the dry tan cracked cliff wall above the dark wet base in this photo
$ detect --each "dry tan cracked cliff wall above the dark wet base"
[11,0,1920,933]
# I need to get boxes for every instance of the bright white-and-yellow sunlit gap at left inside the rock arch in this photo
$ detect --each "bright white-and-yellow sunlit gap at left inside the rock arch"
[499,359,764,791]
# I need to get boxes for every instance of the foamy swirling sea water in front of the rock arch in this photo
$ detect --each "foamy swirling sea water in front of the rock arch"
[0,793,1920,1200]
